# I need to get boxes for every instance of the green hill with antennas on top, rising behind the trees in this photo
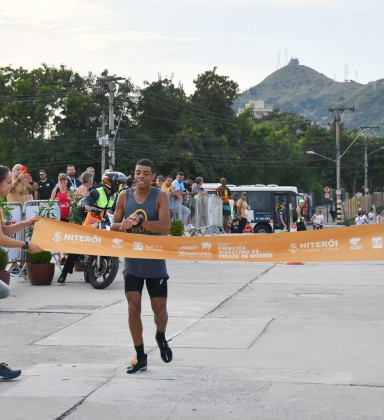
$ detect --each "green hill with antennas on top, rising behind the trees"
[233,59,384,129]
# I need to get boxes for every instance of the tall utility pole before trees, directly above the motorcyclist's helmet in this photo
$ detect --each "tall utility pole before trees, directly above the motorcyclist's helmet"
[98,76,125,173]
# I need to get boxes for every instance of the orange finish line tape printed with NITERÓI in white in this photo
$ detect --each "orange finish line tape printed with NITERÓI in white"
[32,218,384,262]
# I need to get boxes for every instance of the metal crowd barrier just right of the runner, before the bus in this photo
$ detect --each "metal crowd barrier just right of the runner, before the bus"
[170,194,224,236]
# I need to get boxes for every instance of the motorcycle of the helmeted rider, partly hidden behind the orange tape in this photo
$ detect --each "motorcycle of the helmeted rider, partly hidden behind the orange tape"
[78,213,120,289]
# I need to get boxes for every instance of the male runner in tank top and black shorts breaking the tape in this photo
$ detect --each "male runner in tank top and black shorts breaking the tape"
[111,159,172,374]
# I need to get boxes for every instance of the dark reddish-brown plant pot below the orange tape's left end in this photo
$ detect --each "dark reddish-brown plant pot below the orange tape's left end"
[27,251,55,286]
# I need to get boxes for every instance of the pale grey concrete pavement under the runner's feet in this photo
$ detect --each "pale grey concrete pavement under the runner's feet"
[0,261,384,420]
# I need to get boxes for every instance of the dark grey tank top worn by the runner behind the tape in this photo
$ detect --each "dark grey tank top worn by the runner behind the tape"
[123,188,168,279]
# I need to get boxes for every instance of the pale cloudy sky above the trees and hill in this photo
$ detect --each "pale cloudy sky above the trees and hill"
[0,0,384,94]
